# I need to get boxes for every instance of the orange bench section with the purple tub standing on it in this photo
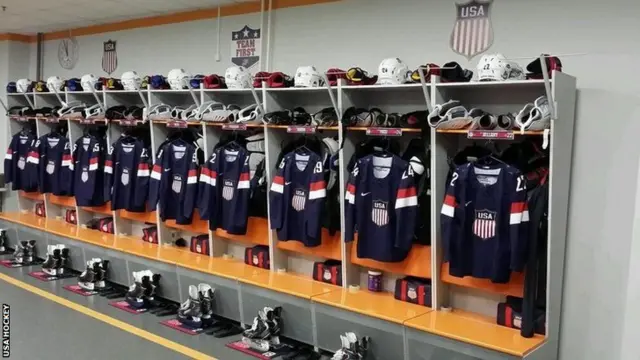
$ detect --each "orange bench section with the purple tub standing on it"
[312,289,432,324]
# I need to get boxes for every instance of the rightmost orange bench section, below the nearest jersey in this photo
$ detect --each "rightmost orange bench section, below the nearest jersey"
[404,310,545,357]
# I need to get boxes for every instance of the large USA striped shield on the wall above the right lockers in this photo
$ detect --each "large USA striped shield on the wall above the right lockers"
[450,0,493,60]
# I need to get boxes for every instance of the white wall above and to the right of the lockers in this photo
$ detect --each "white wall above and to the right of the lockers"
[7,0,640,360]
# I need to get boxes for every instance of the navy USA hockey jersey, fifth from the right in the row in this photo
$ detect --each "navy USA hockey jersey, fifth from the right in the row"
[149,140,198,225]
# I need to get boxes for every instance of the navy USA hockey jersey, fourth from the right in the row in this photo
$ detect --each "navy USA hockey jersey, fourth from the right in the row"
[198,147,251,235]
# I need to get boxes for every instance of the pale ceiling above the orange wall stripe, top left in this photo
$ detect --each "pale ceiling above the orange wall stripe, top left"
[0,0,256,34]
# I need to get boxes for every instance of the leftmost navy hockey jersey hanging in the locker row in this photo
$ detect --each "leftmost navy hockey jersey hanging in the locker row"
[4,132,38,192]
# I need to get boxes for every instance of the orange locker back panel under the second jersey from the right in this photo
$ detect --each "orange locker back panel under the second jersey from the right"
[351,238,431,279]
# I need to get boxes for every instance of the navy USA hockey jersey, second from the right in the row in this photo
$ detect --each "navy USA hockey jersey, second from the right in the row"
[345,155,418,262]
